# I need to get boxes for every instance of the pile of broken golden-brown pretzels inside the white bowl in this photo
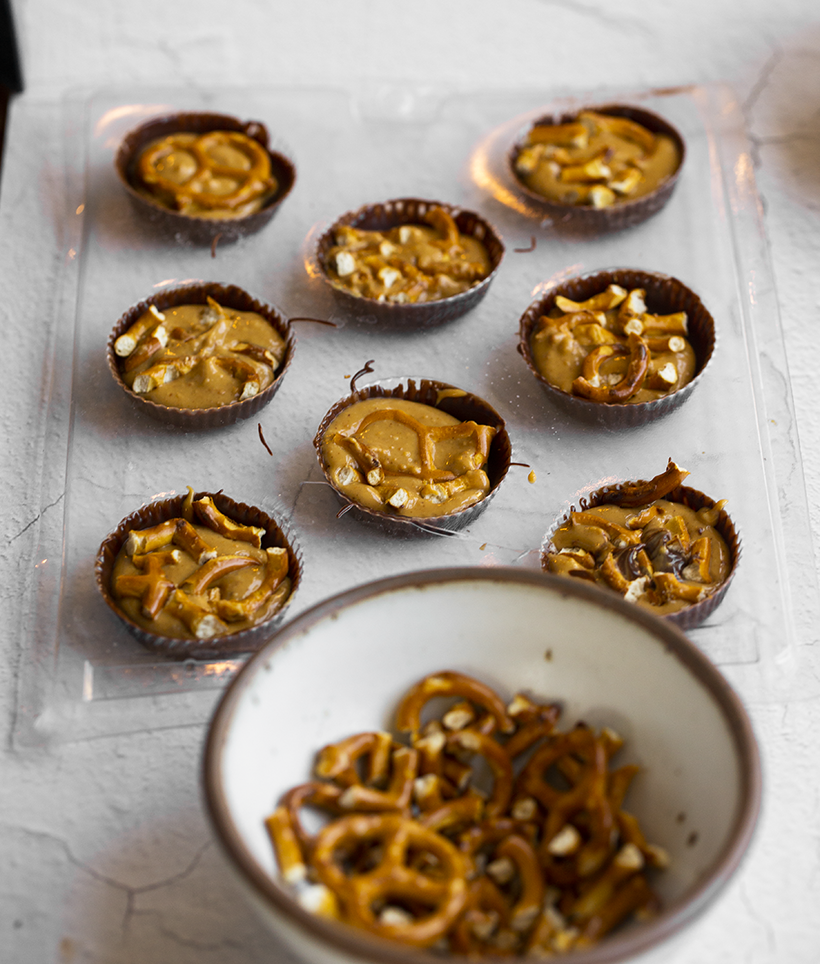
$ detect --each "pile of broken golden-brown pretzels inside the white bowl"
[266,671,668,957]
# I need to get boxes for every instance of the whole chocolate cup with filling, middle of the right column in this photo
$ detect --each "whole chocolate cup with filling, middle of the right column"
[518,268,715,427]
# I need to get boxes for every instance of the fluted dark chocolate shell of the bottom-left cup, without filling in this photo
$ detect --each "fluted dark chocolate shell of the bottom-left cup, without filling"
[94,491,303,659]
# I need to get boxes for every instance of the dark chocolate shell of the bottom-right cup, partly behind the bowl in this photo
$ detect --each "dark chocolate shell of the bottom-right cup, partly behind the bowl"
[541,482,741,629]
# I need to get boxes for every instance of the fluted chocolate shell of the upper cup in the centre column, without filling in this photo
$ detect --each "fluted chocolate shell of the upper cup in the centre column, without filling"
[315,198,504,329]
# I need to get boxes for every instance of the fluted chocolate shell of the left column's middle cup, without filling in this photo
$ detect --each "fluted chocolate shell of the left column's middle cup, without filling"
[107,282,296,431]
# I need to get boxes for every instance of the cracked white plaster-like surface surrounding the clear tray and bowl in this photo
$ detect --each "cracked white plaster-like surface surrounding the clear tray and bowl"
[0,0,820,964]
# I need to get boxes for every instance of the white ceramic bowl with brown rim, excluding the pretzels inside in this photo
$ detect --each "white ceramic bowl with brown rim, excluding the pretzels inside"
[204,569,761,964]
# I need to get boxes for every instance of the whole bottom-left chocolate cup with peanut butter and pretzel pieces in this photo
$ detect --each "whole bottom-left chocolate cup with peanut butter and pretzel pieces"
[95,490,302,659]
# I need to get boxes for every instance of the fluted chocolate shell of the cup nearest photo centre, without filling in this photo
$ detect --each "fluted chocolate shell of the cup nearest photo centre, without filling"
[313,378,512,534]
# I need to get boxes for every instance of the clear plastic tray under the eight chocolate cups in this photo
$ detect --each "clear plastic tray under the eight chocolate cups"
[16,86,816,744]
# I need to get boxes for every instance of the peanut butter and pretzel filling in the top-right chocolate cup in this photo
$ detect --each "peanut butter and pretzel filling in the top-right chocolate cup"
[515,111,681,208]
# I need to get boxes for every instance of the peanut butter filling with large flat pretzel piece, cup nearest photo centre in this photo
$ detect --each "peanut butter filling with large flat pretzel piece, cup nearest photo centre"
[322,398,496,518]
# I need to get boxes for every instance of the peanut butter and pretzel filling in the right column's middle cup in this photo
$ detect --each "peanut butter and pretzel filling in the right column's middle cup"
[530,284,697,404]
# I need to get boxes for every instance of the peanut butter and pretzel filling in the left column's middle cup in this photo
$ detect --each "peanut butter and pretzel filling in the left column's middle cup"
[114,298,285,408]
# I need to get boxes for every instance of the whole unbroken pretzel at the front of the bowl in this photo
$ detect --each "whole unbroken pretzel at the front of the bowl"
[313,814,467,947]
